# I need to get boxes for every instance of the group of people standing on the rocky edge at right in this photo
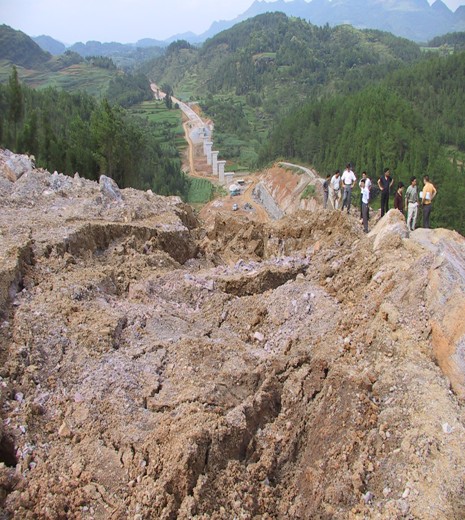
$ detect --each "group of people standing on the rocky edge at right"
[323,164,437,233]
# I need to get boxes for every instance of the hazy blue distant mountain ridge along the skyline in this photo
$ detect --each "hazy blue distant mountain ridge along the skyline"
[33,0,465,53]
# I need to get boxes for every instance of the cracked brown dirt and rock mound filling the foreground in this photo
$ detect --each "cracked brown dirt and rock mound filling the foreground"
[0,152,465,520]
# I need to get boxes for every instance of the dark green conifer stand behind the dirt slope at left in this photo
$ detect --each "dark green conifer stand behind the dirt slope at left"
[0,69,187,195]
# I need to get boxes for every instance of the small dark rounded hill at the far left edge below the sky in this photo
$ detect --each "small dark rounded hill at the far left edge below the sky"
[0,25,51,69]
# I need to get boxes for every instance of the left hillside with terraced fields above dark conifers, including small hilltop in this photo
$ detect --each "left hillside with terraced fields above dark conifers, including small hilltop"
[0,26,188,196]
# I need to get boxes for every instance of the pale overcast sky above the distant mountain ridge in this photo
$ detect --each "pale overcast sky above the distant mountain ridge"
[0,0,465,44]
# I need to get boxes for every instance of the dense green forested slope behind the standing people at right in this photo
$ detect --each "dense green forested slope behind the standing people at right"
[261,52,465,234]
